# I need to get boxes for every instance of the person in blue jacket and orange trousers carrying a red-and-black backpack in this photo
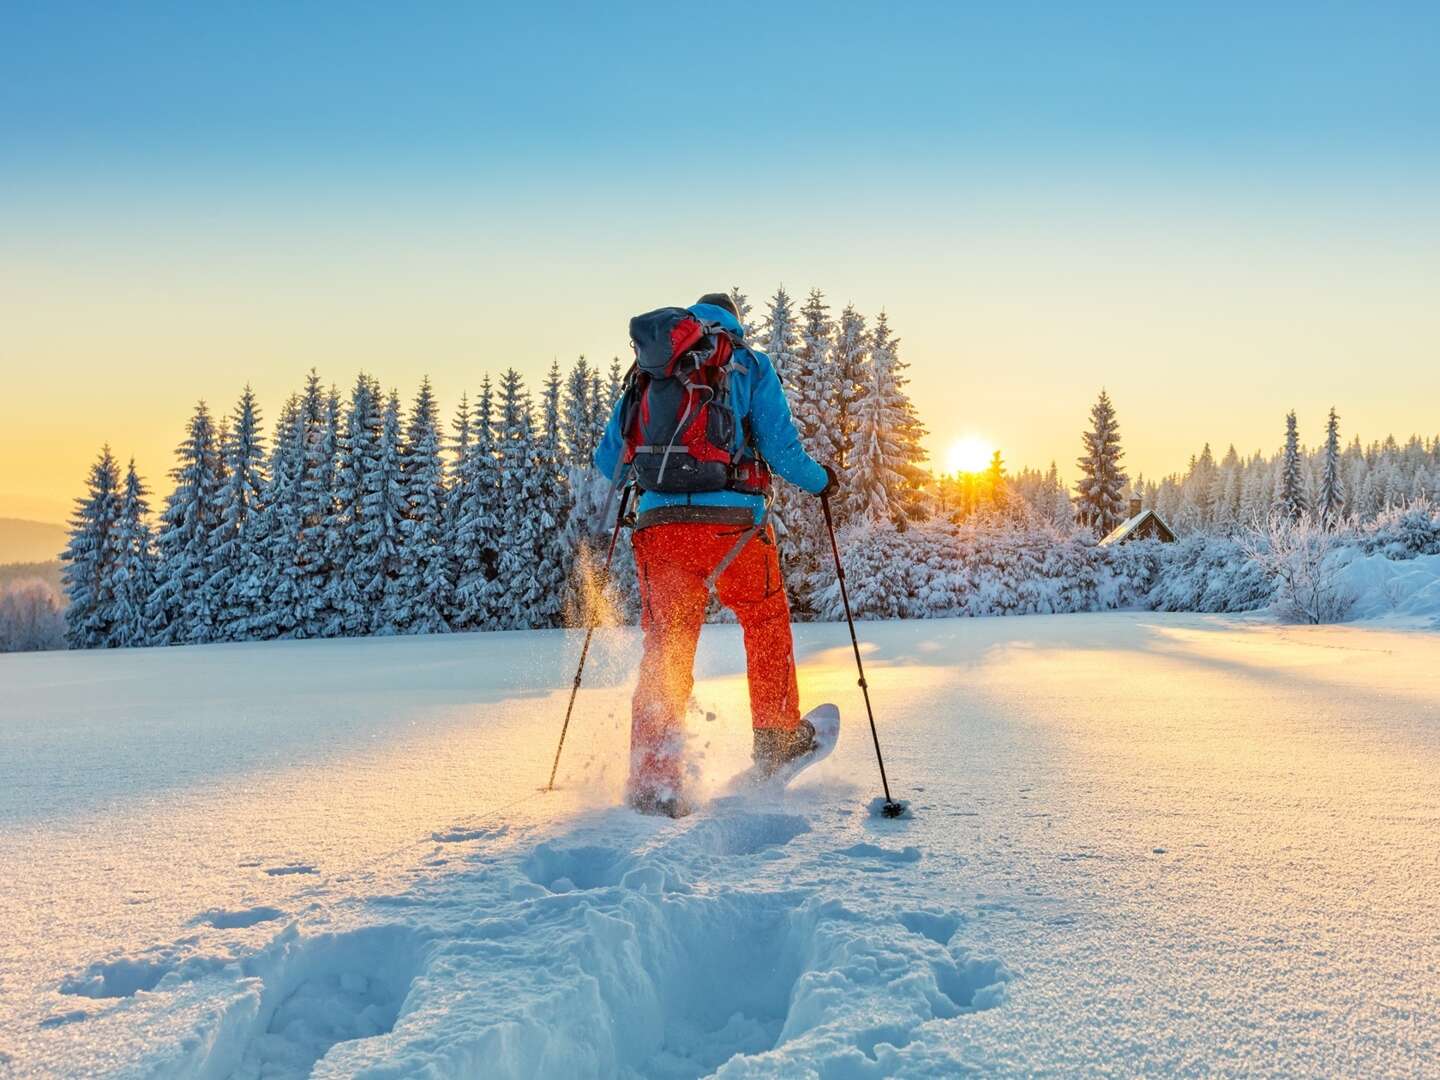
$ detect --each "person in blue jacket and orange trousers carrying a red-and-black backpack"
[595,292,835,816]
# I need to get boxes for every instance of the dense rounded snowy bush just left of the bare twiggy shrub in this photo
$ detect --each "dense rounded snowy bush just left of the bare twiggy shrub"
[1145,533,1276,612]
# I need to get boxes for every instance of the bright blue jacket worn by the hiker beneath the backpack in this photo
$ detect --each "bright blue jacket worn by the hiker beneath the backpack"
[595,304,827,523]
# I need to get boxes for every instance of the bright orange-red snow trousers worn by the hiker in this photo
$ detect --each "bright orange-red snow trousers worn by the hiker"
[631,521,801,775]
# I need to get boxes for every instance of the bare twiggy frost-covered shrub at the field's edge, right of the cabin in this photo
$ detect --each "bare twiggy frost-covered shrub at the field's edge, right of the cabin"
[1237,514,1355,624]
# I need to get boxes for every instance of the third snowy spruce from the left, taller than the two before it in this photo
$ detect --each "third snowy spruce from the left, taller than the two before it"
[147,402,222,645]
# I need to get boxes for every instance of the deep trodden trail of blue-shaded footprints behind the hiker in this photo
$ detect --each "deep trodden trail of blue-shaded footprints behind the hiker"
[104,801,1011,1080]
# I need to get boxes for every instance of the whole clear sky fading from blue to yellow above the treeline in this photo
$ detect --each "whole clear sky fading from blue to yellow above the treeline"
[0,0,1440,508]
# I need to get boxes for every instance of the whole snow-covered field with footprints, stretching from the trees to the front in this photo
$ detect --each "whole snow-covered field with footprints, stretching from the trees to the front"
[0,613,1440,1080]
